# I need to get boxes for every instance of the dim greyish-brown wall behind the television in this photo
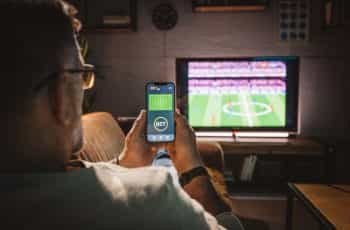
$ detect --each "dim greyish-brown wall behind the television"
[88,0,350,180]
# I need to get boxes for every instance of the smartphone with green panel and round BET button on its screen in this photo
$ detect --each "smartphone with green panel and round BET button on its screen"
[146,82,175,142]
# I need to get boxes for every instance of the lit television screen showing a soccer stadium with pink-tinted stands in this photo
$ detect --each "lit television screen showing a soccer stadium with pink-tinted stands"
[188,61,287,128]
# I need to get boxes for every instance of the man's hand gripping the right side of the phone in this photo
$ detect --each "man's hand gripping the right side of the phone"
[168,111,204,175]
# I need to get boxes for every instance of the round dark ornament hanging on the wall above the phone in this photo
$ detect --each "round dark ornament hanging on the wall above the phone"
[152,4,178,30]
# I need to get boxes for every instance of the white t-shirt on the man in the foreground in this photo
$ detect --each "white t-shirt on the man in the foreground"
[0,162,242,230]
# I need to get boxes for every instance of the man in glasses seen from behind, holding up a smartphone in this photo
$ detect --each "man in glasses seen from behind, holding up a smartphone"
[0,0,240,229]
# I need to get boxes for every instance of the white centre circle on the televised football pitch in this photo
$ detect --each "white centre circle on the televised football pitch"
[223,102,272,117]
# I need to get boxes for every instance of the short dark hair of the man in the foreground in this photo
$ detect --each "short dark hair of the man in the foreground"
[0,0,75,108]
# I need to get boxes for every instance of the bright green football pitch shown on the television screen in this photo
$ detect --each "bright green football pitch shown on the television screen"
[188,94,286,127]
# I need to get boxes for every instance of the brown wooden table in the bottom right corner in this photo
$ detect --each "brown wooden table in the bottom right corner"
[286,184,350,230]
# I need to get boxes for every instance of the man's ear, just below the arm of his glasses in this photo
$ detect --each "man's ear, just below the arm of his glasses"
[49,75,74,126]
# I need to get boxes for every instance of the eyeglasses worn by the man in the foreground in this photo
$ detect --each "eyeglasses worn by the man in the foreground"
[33,64,95,92]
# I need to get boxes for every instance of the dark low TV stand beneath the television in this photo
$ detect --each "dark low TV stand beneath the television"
[213,137,335,194]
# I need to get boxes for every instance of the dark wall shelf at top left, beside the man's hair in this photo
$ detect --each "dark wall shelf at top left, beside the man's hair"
[68,0,137,31]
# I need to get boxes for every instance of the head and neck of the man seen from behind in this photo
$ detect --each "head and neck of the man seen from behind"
[0,0,89,171]
